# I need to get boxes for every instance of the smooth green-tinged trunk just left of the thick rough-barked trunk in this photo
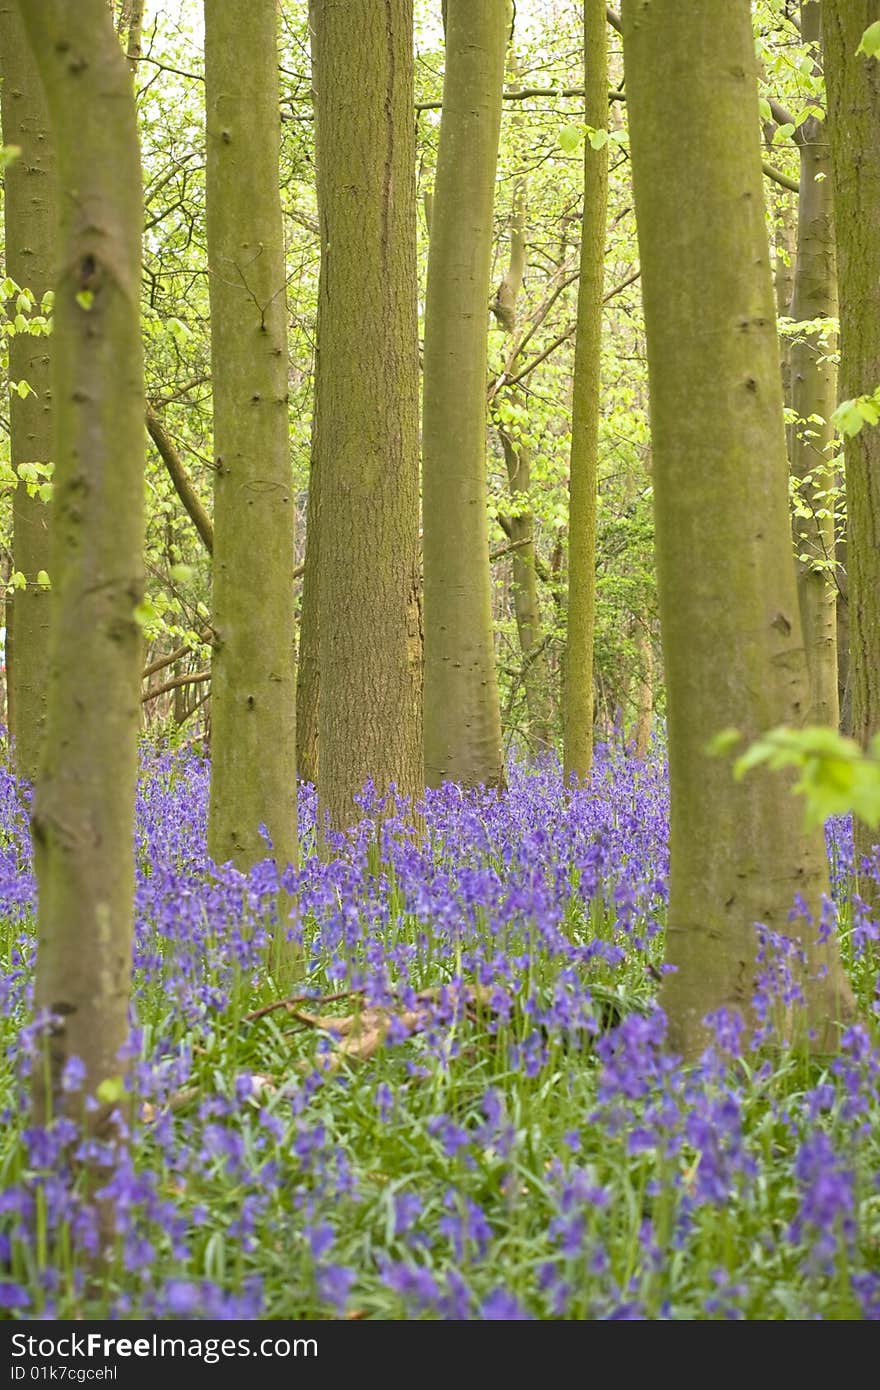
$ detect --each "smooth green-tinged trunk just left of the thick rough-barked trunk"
[204,0,296,870]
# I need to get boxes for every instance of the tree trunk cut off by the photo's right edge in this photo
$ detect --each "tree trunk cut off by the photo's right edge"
[822,0,880,889]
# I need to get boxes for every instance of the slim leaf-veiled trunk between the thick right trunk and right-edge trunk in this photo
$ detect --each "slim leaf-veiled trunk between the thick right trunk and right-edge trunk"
[790,0,840,728]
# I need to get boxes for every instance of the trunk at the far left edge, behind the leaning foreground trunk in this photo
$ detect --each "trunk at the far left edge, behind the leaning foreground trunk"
[0,3,58,781]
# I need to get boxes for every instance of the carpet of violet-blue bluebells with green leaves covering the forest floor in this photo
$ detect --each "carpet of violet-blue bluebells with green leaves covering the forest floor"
[0,749,880,1319]
